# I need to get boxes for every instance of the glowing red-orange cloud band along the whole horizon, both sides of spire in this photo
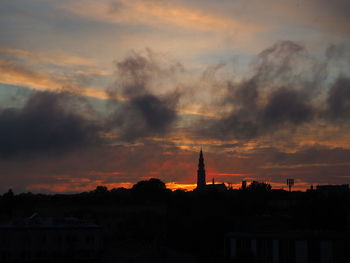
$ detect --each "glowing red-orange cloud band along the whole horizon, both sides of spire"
[0,138,350,192]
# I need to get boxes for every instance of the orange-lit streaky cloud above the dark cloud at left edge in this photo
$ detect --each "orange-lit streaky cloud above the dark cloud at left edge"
[0,46,107,99]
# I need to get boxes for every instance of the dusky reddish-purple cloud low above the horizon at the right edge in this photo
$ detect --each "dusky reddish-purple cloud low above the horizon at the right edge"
[252,145,350,184]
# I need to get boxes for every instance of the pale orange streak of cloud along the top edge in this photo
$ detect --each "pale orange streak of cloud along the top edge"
[62,0,262,33]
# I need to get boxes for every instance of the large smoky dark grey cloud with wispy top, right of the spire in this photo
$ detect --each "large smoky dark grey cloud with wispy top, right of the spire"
[195,41,350,140]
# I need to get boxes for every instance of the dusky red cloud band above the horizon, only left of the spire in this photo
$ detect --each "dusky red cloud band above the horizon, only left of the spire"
[0,141,197,192]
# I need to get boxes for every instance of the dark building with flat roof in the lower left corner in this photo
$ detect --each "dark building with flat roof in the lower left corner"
[0,214,102,262]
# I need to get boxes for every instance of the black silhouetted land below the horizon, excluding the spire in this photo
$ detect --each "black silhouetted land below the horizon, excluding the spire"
[0,179,350,262]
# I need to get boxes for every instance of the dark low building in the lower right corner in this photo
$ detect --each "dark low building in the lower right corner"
[225,231,350,263]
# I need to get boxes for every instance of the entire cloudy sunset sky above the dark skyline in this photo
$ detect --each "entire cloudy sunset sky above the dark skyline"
[0,0,350,193]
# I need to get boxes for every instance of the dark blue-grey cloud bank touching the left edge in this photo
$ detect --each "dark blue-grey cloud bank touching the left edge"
[0,92,99,158]
